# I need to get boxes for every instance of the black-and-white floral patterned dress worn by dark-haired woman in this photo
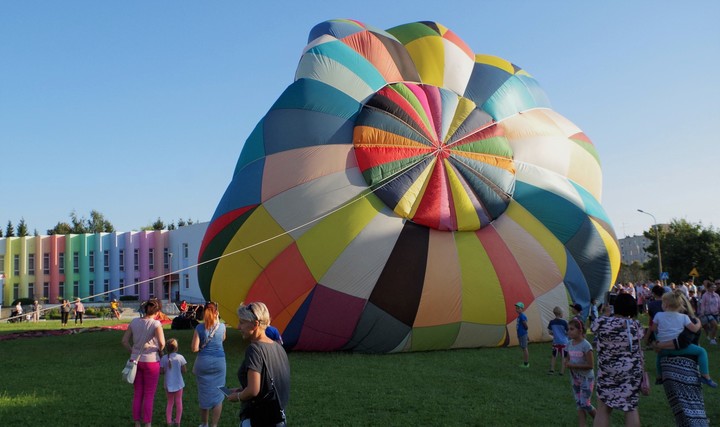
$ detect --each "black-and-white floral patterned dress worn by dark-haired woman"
[592,316,645,412]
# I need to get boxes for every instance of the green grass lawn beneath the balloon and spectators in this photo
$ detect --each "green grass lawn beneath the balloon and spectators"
[0,320,720,426]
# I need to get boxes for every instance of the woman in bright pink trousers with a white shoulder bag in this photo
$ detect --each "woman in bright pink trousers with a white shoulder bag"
[122,299,165,427]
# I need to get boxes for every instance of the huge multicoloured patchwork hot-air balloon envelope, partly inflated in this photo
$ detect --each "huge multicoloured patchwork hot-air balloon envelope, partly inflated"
[198,20,620,353]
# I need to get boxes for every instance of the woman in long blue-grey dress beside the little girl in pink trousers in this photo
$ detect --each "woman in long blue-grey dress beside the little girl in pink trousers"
[190,302,226,427]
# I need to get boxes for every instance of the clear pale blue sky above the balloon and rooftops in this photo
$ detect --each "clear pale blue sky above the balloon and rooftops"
[0,0,720,238]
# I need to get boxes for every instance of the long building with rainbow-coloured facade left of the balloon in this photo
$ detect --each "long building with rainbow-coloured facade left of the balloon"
[0,223,208,305]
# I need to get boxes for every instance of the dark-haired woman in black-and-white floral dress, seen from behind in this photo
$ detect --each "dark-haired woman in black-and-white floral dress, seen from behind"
[592,294,644,427]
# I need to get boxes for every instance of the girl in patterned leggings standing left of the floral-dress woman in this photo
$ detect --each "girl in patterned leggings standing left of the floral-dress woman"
[564,319,595,426]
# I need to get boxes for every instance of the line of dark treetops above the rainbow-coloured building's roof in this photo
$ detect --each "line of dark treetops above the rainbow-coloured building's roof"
[0,210,198,237]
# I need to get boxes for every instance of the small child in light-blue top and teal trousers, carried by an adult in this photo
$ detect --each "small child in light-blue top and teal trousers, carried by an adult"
[650,290,717,388]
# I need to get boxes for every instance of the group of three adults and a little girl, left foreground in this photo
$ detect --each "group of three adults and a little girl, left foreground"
[122,299,290,427]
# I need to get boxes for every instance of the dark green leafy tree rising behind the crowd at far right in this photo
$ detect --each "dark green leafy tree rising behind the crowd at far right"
[644,219,720,282]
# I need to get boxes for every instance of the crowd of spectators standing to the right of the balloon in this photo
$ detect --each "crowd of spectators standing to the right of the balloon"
[515,280,720,426]
